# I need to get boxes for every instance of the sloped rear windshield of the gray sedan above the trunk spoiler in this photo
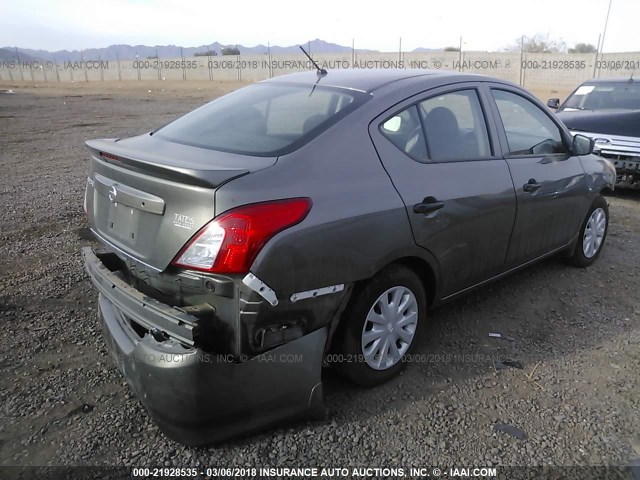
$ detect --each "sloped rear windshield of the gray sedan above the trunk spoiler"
[154,83,369,156]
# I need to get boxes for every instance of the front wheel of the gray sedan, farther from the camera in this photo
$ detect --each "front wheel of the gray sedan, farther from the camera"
[569,195,609,268]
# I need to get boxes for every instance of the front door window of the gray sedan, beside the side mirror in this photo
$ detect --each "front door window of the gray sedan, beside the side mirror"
[491,89,567,156]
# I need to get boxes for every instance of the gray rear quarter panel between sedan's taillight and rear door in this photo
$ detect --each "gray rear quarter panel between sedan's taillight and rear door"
[216,106,423,297]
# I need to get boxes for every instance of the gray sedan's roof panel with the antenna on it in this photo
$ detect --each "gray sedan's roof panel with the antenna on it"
[261,68,487,93]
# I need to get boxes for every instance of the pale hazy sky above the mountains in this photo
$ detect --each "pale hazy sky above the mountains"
[0,0,640,52]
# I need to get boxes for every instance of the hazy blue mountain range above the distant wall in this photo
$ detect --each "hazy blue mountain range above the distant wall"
[0,38,437,63]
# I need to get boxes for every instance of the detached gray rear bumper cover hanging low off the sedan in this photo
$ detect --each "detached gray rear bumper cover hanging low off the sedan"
[82,248,327,445]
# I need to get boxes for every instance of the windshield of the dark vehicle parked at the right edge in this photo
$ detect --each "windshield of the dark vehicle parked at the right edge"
[562,82,640,111]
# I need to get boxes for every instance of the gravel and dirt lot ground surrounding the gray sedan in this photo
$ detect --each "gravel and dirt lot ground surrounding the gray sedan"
[0,82,640,472]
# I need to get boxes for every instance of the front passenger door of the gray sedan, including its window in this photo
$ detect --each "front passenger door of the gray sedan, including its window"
[485,84,586,268]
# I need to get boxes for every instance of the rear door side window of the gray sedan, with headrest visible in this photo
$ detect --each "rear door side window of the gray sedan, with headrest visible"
[380,89,491,163]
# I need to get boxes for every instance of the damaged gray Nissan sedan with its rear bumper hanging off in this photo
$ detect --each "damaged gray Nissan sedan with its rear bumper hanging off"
[82,70,615,444]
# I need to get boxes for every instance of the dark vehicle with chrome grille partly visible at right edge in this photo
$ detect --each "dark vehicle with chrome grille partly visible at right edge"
[547,76,640,185]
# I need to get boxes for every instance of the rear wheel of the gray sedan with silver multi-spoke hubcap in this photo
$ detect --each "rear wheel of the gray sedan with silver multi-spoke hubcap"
[338,265,427,387]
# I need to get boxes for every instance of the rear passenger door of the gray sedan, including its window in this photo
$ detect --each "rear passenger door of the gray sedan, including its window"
[370,83,515,296]
